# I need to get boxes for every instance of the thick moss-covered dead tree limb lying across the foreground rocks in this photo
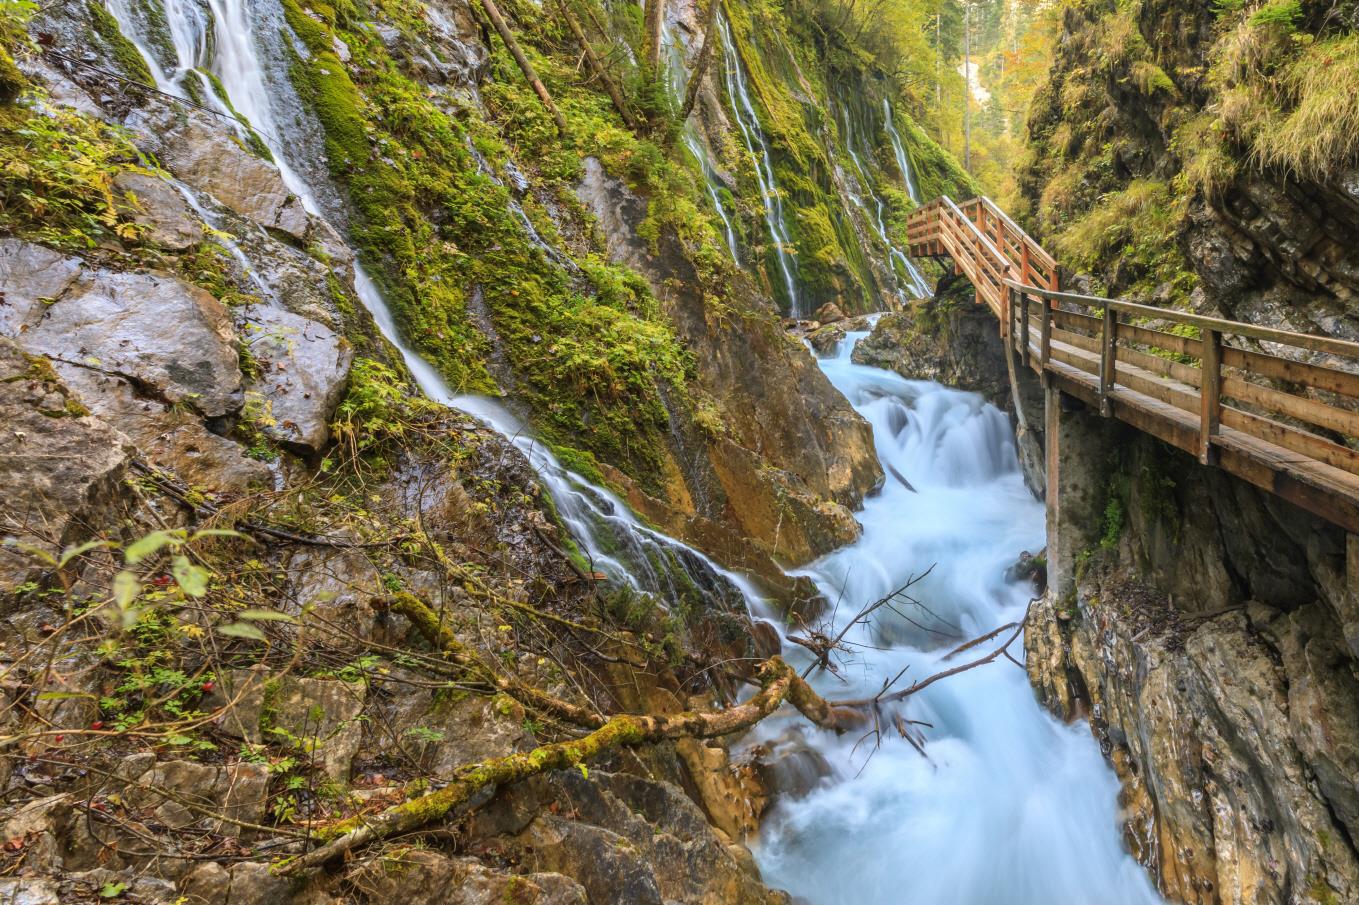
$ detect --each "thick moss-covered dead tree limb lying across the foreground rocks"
[279,656,863,875]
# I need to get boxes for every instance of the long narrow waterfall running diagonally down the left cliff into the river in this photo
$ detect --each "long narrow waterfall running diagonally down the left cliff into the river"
[109,0,765,611]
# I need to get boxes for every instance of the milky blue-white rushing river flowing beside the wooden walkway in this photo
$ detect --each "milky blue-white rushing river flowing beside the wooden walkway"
[757,327,1161,905]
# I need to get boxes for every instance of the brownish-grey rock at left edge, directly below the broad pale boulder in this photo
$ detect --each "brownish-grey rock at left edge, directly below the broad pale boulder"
[0,338,132,591]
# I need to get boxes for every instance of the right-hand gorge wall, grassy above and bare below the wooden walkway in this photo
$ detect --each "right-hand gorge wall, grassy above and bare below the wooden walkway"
[1019,0,1359,904]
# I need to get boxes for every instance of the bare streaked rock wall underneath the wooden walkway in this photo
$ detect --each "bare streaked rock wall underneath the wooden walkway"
[1025,413,1359,905]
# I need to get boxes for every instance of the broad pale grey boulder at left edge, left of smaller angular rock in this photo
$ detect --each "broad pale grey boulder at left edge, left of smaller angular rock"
[0,254,241,417]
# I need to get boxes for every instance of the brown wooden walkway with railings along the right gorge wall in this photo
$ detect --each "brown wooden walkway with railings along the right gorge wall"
[908,197,1359,534]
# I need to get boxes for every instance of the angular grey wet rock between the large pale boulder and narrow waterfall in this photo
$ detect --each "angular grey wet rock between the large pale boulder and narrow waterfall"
[242,304,353,453]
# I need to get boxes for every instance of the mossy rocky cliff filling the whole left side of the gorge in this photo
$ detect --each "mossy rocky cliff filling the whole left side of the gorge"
[0,0,978,905]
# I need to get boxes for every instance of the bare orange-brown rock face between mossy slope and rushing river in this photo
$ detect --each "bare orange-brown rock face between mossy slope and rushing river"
[578,159,882,571]
